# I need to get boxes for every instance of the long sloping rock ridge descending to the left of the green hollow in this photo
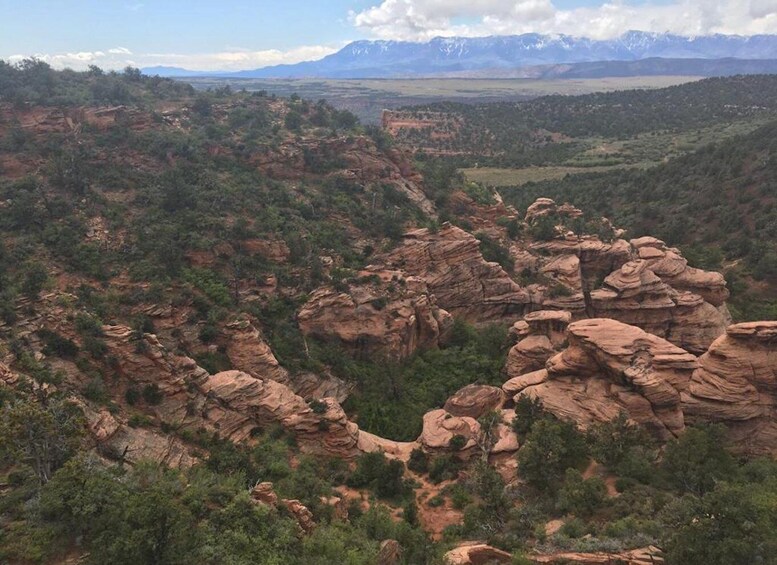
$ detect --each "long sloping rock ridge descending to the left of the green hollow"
[97,326,366,458]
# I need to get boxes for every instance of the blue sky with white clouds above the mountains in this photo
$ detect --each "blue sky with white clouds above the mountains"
[0,0,777,71]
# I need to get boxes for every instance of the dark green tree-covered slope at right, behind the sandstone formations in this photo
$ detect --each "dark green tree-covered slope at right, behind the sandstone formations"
[501,122,777,319]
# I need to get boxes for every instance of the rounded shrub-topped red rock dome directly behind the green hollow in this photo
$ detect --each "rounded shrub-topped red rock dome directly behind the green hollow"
[297,270,453,360]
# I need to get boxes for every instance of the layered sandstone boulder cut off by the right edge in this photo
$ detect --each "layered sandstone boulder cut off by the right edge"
[683,322,777,454]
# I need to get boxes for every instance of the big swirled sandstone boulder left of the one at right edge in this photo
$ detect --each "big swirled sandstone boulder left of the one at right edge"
[516,319,698,439]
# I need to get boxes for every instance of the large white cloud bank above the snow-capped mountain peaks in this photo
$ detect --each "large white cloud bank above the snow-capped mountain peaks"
[349,0,777,41]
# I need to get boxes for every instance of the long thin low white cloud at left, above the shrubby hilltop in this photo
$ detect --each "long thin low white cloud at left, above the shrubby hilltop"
[8,43,345,71]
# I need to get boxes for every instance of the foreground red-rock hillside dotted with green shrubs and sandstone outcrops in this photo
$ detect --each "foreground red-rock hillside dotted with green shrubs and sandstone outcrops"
[0,61,777,565]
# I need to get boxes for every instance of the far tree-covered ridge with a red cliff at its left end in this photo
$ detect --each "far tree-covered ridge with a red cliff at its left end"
[383,75,777,167]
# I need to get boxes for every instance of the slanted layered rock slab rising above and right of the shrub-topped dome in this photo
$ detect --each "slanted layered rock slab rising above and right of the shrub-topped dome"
[385,223,535,323]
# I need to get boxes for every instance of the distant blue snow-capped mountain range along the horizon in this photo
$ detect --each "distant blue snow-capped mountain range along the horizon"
[143,31,777,78]
